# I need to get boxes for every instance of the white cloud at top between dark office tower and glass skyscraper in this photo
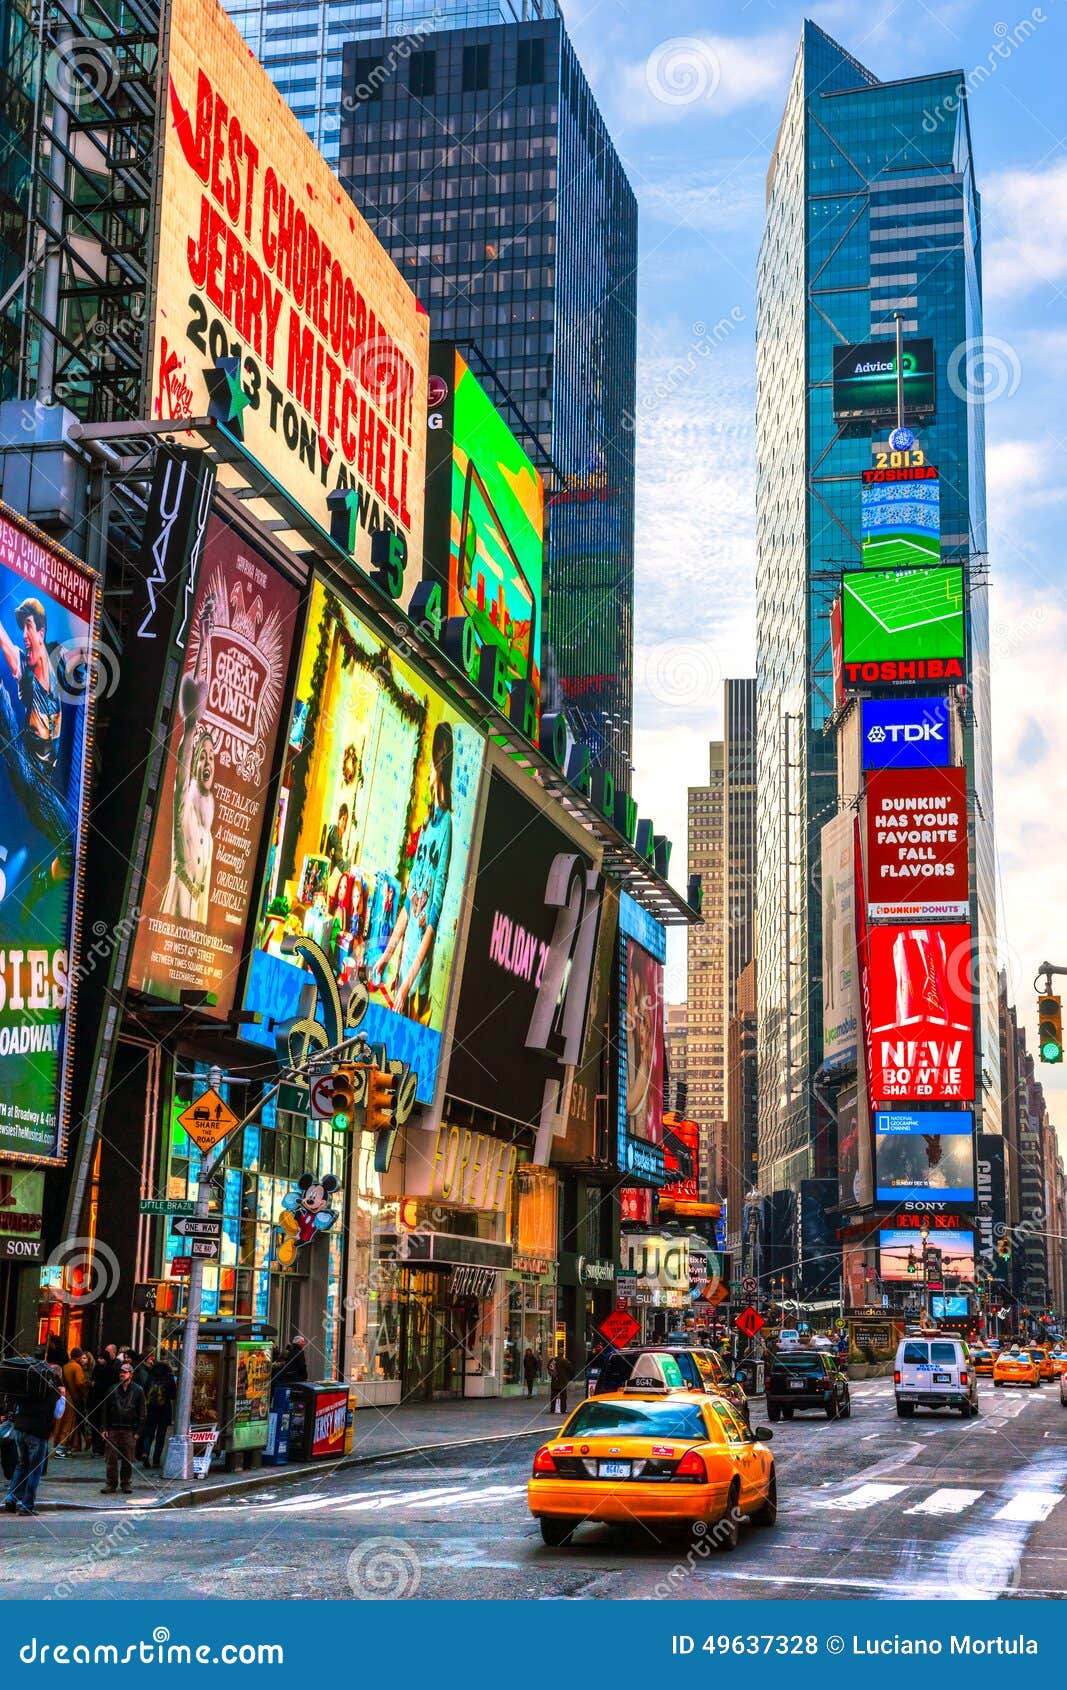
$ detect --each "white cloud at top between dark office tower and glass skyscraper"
[621,30,796,123]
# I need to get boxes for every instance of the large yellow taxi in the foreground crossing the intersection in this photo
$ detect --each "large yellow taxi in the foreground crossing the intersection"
[526,1389,778,1550]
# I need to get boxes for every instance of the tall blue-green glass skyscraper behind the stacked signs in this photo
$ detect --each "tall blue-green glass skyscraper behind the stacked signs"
[756,22,999,1216]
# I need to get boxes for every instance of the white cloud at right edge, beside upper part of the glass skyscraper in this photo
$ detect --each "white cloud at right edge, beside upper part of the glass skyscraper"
[982,159,1067,301]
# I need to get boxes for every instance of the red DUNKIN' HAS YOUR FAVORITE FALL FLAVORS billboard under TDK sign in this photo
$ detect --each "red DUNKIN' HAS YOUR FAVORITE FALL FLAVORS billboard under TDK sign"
[864,769,969,921]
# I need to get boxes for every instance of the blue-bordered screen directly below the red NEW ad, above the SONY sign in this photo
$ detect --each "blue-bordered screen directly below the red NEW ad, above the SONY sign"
[874,1109,974,1203]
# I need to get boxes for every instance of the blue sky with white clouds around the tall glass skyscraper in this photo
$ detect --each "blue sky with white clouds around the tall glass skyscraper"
[565,0,1067,1127]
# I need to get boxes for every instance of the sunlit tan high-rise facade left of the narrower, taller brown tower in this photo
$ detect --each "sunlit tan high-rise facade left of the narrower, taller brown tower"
[687,740,725,1202]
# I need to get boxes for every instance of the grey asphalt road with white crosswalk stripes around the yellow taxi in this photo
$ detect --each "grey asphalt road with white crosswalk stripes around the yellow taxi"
[0,1381,1067,1600]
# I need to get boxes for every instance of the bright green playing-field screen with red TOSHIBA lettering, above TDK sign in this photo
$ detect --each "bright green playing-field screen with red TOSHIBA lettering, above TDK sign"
[840,563,964,684]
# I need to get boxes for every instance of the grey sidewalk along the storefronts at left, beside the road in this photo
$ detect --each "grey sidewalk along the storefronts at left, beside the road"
[18,1389,568,1513]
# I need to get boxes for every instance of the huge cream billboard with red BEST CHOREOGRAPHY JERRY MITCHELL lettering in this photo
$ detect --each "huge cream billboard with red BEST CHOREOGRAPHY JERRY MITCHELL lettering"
[150,0,430,588]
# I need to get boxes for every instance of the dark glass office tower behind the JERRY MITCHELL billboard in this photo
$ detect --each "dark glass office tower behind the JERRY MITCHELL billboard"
[338,15,637,786]
